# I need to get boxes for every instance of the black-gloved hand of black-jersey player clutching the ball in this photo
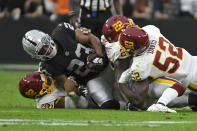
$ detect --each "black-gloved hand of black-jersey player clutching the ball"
[87,54,105,71]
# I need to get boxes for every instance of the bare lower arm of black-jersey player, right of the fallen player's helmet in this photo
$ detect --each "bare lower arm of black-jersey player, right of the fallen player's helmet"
[64,76,78,93]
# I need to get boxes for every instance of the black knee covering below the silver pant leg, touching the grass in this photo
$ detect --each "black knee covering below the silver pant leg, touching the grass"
[101,100,120,110]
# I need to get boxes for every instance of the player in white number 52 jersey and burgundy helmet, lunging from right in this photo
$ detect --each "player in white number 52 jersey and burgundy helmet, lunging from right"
[119,25,197,112]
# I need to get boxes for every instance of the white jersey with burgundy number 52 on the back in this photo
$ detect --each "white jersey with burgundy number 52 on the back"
[119,25,197,89]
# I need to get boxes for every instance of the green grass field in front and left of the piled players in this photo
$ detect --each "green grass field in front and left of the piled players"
[0,71,197,131]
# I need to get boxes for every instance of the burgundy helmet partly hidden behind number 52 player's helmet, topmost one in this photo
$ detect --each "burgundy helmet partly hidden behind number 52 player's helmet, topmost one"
[102,15,135,42]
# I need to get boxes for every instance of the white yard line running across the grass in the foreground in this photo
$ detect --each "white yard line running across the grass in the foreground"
[0,119,197,127]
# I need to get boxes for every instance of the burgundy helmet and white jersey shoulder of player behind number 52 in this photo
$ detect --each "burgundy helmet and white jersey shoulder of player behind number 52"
[101,15,137,63]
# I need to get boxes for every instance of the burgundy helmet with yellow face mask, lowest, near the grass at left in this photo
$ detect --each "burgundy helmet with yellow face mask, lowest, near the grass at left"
[19,72,55,99]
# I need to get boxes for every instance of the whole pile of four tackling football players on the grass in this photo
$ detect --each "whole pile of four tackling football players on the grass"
[19,16,197,113]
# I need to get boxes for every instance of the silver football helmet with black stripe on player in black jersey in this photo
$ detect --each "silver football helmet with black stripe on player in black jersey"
[22,30,57,60]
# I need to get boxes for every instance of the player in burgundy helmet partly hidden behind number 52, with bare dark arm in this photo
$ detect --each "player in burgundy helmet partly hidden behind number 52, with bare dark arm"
[101,15,159,109]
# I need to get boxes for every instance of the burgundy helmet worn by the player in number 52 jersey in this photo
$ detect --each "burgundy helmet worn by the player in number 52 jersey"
[119,26,149,56]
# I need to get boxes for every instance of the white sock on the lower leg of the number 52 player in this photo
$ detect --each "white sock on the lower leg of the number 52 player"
[157,88,178,106]
